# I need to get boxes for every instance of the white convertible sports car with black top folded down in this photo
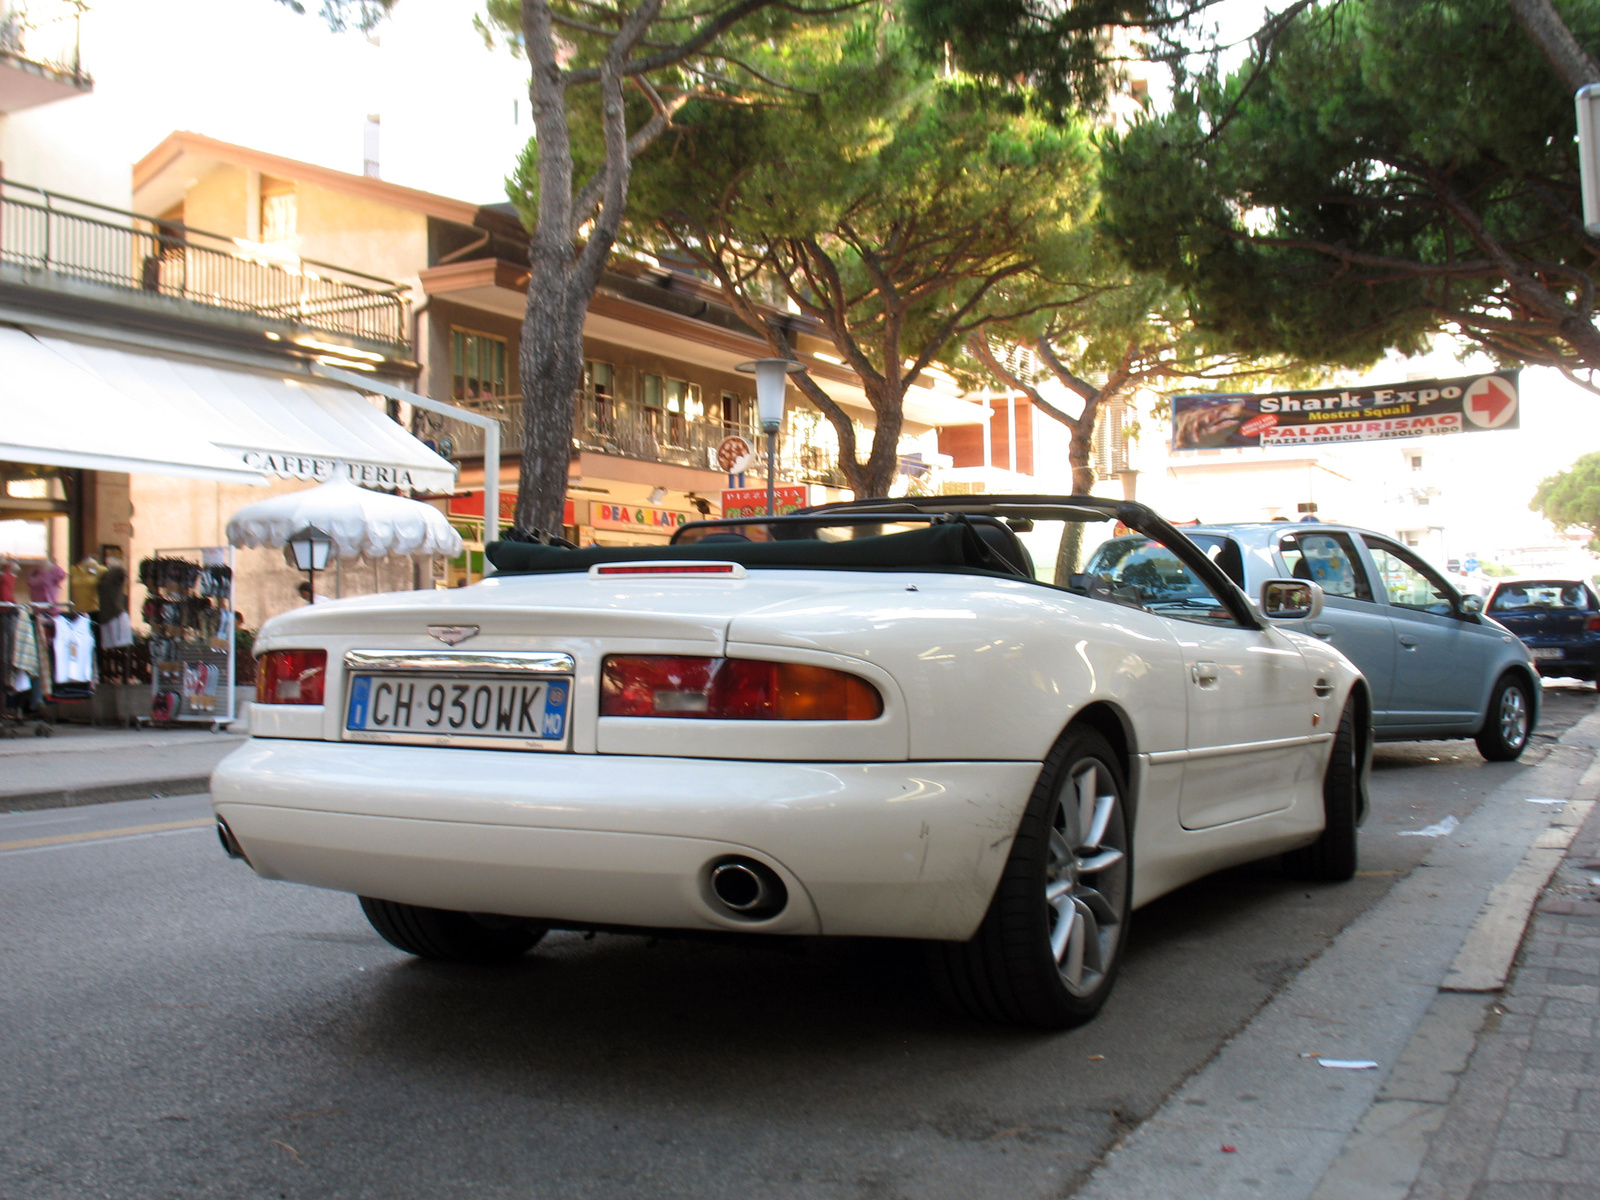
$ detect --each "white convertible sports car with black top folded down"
[211,496,1371,1027]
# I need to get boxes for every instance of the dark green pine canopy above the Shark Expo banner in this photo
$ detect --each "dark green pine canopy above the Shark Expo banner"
[1104,0,1600,386]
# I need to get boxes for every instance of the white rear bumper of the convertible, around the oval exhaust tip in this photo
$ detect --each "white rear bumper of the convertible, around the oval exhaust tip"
[211,738,1040,939]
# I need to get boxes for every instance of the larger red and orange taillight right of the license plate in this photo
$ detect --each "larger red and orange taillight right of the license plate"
[600,654,883,722]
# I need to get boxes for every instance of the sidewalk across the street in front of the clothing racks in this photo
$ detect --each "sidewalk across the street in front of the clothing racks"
[0,725,245,813]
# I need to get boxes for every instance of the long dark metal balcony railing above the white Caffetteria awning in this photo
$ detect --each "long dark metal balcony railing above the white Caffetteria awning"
[0,179,411,355]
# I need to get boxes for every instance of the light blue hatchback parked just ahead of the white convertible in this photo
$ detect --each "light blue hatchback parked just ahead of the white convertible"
[1164,522,1539,762]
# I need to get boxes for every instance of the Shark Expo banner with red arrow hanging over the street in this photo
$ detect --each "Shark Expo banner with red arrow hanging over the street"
[1173,371,1518,450]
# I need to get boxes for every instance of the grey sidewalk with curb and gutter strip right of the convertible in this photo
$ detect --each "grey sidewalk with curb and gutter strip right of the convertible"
[1078,714,1600,1200]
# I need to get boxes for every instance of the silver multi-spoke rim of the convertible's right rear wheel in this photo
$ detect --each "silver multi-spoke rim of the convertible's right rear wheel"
[1045,758,1128,997]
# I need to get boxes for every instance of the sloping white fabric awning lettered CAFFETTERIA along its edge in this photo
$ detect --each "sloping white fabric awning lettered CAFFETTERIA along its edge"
[0,326,456,491]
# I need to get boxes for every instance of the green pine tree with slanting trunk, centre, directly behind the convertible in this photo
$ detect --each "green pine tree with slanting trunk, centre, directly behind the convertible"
[601,5,1094,496]
